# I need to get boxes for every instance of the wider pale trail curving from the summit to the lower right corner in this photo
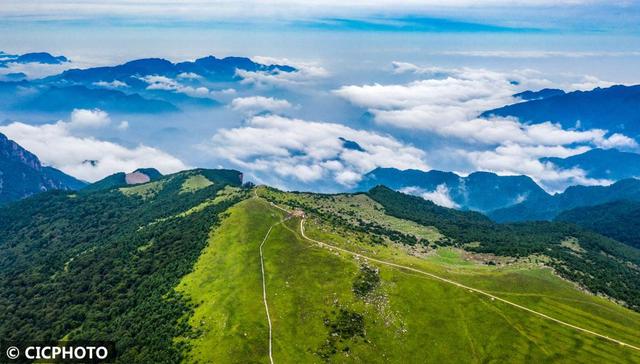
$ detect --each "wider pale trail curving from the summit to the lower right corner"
[256,195,640,351]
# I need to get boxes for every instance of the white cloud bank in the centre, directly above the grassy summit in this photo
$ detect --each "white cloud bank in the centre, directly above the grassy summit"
[206,115,428,186]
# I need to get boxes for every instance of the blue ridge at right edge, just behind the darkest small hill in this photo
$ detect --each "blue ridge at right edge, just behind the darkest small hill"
[488,178,640,222]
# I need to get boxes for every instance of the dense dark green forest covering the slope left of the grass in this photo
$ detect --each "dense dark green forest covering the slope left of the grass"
[0,171,241,363]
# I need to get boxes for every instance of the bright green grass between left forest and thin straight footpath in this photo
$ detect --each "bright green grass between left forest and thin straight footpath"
[176,199,281,363]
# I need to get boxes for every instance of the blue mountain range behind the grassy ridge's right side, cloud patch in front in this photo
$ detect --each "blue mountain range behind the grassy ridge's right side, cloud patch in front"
[354,149,640,215]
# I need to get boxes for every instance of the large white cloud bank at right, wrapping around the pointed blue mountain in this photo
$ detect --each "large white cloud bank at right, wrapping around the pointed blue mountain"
[334,62,638,191]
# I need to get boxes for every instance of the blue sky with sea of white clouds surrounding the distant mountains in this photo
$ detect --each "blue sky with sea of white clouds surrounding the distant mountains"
[0,0,640,196]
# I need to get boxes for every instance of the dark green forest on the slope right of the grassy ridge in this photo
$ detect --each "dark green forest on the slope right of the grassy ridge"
[368,186,640,310]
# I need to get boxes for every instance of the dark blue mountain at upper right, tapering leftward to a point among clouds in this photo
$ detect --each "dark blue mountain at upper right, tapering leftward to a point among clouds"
[482,85,640,137]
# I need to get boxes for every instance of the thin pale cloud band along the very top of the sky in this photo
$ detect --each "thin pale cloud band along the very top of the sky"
[0,0,620,21]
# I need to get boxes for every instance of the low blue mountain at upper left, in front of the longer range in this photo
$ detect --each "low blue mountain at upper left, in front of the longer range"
[18,85,179,113]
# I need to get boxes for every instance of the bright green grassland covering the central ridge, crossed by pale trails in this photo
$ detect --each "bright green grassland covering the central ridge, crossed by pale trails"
[176,190,640,363]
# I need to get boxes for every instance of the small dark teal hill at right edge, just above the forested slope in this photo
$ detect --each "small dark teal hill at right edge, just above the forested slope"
[555,200,640,248]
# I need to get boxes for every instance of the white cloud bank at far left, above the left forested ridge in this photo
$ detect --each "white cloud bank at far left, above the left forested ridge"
[0,110,188,182]
